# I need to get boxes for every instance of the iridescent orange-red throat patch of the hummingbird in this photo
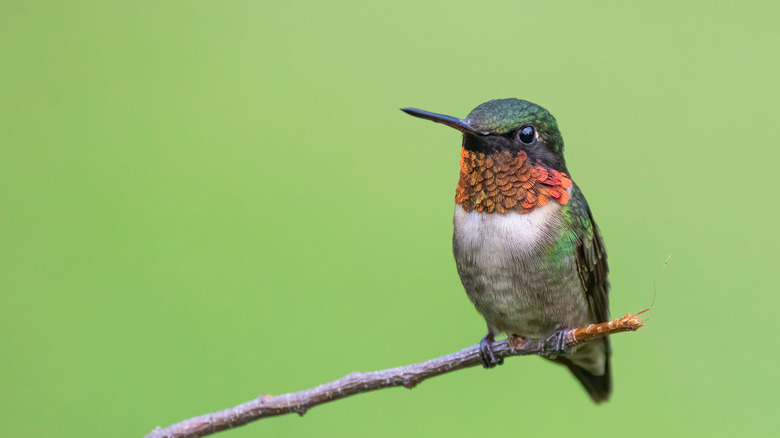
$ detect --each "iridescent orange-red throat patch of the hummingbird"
[455,148,571,213]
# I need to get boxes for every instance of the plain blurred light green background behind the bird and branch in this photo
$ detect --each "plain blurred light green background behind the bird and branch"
[0,0,780,438]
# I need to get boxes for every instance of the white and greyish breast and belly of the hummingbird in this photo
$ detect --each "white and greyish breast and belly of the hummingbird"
[453,202,587,336]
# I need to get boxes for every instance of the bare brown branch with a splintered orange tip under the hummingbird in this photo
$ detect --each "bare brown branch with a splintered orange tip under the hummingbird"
[146,310,647,438]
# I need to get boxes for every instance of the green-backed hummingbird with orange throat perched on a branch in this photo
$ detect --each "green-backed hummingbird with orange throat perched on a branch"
[402,99,612,403]
